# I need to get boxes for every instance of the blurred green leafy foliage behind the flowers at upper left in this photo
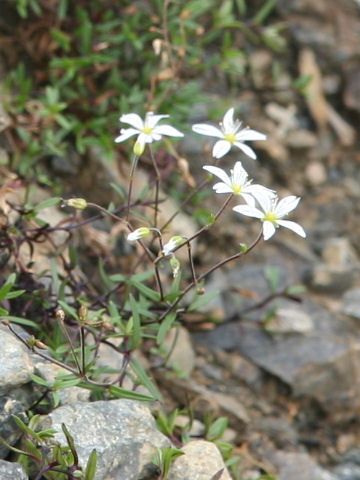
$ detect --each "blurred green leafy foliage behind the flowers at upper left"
[5,0,290,177]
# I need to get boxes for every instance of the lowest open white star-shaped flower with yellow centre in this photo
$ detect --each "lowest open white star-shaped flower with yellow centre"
[233,195,306,240]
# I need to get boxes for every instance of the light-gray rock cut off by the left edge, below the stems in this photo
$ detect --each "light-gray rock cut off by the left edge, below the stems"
[0,325,34,395]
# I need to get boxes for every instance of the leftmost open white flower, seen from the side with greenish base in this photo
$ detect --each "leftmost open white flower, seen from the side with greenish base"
[115,112,184,155]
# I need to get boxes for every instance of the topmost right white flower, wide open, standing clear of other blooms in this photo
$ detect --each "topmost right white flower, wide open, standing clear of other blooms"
[192,108,266,160]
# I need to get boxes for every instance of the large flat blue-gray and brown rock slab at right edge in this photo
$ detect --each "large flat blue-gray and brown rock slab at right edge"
[195,294,360,419]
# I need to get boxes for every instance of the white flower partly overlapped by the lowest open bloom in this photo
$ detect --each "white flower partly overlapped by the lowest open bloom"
[203,162,274,206]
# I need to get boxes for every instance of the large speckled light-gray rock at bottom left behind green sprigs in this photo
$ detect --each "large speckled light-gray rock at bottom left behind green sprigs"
[42,399,170,480]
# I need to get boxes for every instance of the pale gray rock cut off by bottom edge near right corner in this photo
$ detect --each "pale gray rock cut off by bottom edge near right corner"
[270,451,338,480]
